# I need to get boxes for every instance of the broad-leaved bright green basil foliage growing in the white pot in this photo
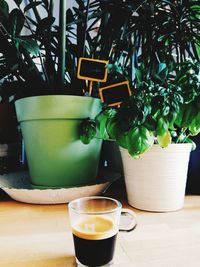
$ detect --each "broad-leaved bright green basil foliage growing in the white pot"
[96,61,200,157]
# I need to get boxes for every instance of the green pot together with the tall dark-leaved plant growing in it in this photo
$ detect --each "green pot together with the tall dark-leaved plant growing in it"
[0,1,101,188]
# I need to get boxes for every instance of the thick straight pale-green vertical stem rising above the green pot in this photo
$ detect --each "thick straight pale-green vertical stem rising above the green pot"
[57,0,67,92]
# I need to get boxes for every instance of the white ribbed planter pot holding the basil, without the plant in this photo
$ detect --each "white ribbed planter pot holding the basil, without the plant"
[120,144,191,212]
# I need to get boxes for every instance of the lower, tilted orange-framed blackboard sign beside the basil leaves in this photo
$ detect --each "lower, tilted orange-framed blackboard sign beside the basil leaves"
[99,81,131,106]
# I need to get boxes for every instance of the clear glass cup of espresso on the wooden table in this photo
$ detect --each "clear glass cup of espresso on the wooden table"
[68,196,136,267]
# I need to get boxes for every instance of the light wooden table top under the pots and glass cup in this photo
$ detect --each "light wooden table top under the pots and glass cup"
[0,186,200,267]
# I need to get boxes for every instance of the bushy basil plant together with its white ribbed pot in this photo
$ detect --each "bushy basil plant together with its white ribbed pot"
[96,61,200,211]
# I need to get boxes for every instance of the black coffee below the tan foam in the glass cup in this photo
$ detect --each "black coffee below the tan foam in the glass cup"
[73,234,117,267]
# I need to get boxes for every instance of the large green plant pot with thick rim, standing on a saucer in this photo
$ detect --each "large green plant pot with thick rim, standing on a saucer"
[15,95,102,188]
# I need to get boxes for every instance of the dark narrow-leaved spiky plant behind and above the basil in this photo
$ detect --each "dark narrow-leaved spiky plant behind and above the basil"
[96,0,200,87]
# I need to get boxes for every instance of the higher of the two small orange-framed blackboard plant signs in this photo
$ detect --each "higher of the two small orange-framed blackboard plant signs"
[77,57,108,82]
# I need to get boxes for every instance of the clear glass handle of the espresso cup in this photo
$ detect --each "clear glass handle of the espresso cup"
[119,208,137,232]
